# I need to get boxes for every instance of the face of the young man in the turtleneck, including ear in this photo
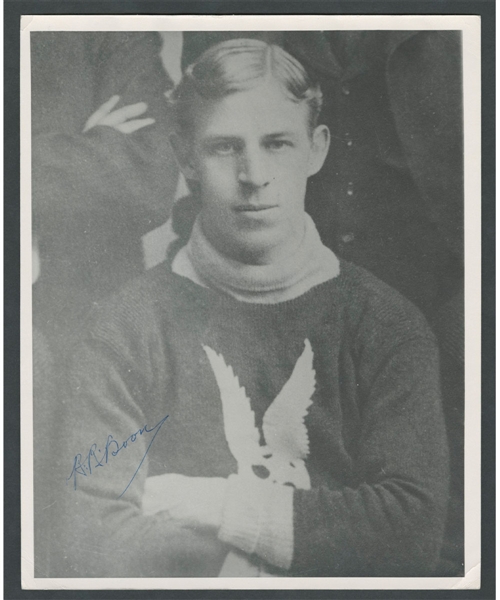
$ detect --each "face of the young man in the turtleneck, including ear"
[184,80,328,264]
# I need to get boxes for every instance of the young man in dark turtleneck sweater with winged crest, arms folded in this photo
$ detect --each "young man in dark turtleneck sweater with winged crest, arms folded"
[61,40,448,577]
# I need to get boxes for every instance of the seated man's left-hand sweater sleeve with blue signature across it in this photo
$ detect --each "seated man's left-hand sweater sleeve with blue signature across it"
[58,312,227,577]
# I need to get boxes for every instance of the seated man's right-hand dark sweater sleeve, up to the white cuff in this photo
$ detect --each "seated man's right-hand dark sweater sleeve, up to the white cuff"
[292,323,448,577]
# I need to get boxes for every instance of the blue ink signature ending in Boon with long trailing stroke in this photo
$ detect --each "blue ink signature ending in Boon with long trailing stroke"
[66,415,168,498]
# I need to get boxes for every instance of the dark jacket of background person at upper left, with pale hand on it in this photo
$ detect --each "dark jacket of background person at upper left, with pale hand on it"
[31,32,178,344]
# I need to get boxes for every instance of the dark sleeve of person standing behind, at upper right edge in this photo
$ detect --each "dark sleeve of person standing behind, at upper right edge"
[387,31,464,261]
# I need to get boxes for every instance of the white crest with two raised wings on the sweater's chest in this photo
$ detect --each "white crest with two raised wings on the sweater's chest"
[203,339,316,490]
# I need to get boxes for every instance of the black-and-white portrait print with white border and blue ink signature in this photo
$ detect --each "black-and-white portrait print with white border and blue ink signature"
[21,16,481,589]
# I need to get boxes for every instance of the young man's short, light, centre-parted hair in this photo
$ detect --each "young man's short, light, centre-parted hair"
[171,38,323,135]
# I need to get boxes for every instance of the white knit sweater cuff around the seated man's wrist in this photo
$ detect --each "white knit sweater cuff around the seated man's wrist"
[219,475,293,569]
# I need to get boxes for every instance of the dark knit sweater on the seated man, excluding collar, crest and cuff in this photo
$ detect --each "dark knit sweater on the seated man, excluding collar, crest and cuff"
[59,262,448,577]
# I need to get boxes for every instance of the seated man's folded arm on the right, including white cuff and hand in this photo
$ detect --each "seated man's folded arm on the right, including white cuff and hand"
[144,339,448,576]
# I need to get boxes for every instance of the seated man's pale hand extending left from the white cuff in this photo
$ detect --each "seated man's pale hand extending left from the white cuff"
[142,473,227,530]
